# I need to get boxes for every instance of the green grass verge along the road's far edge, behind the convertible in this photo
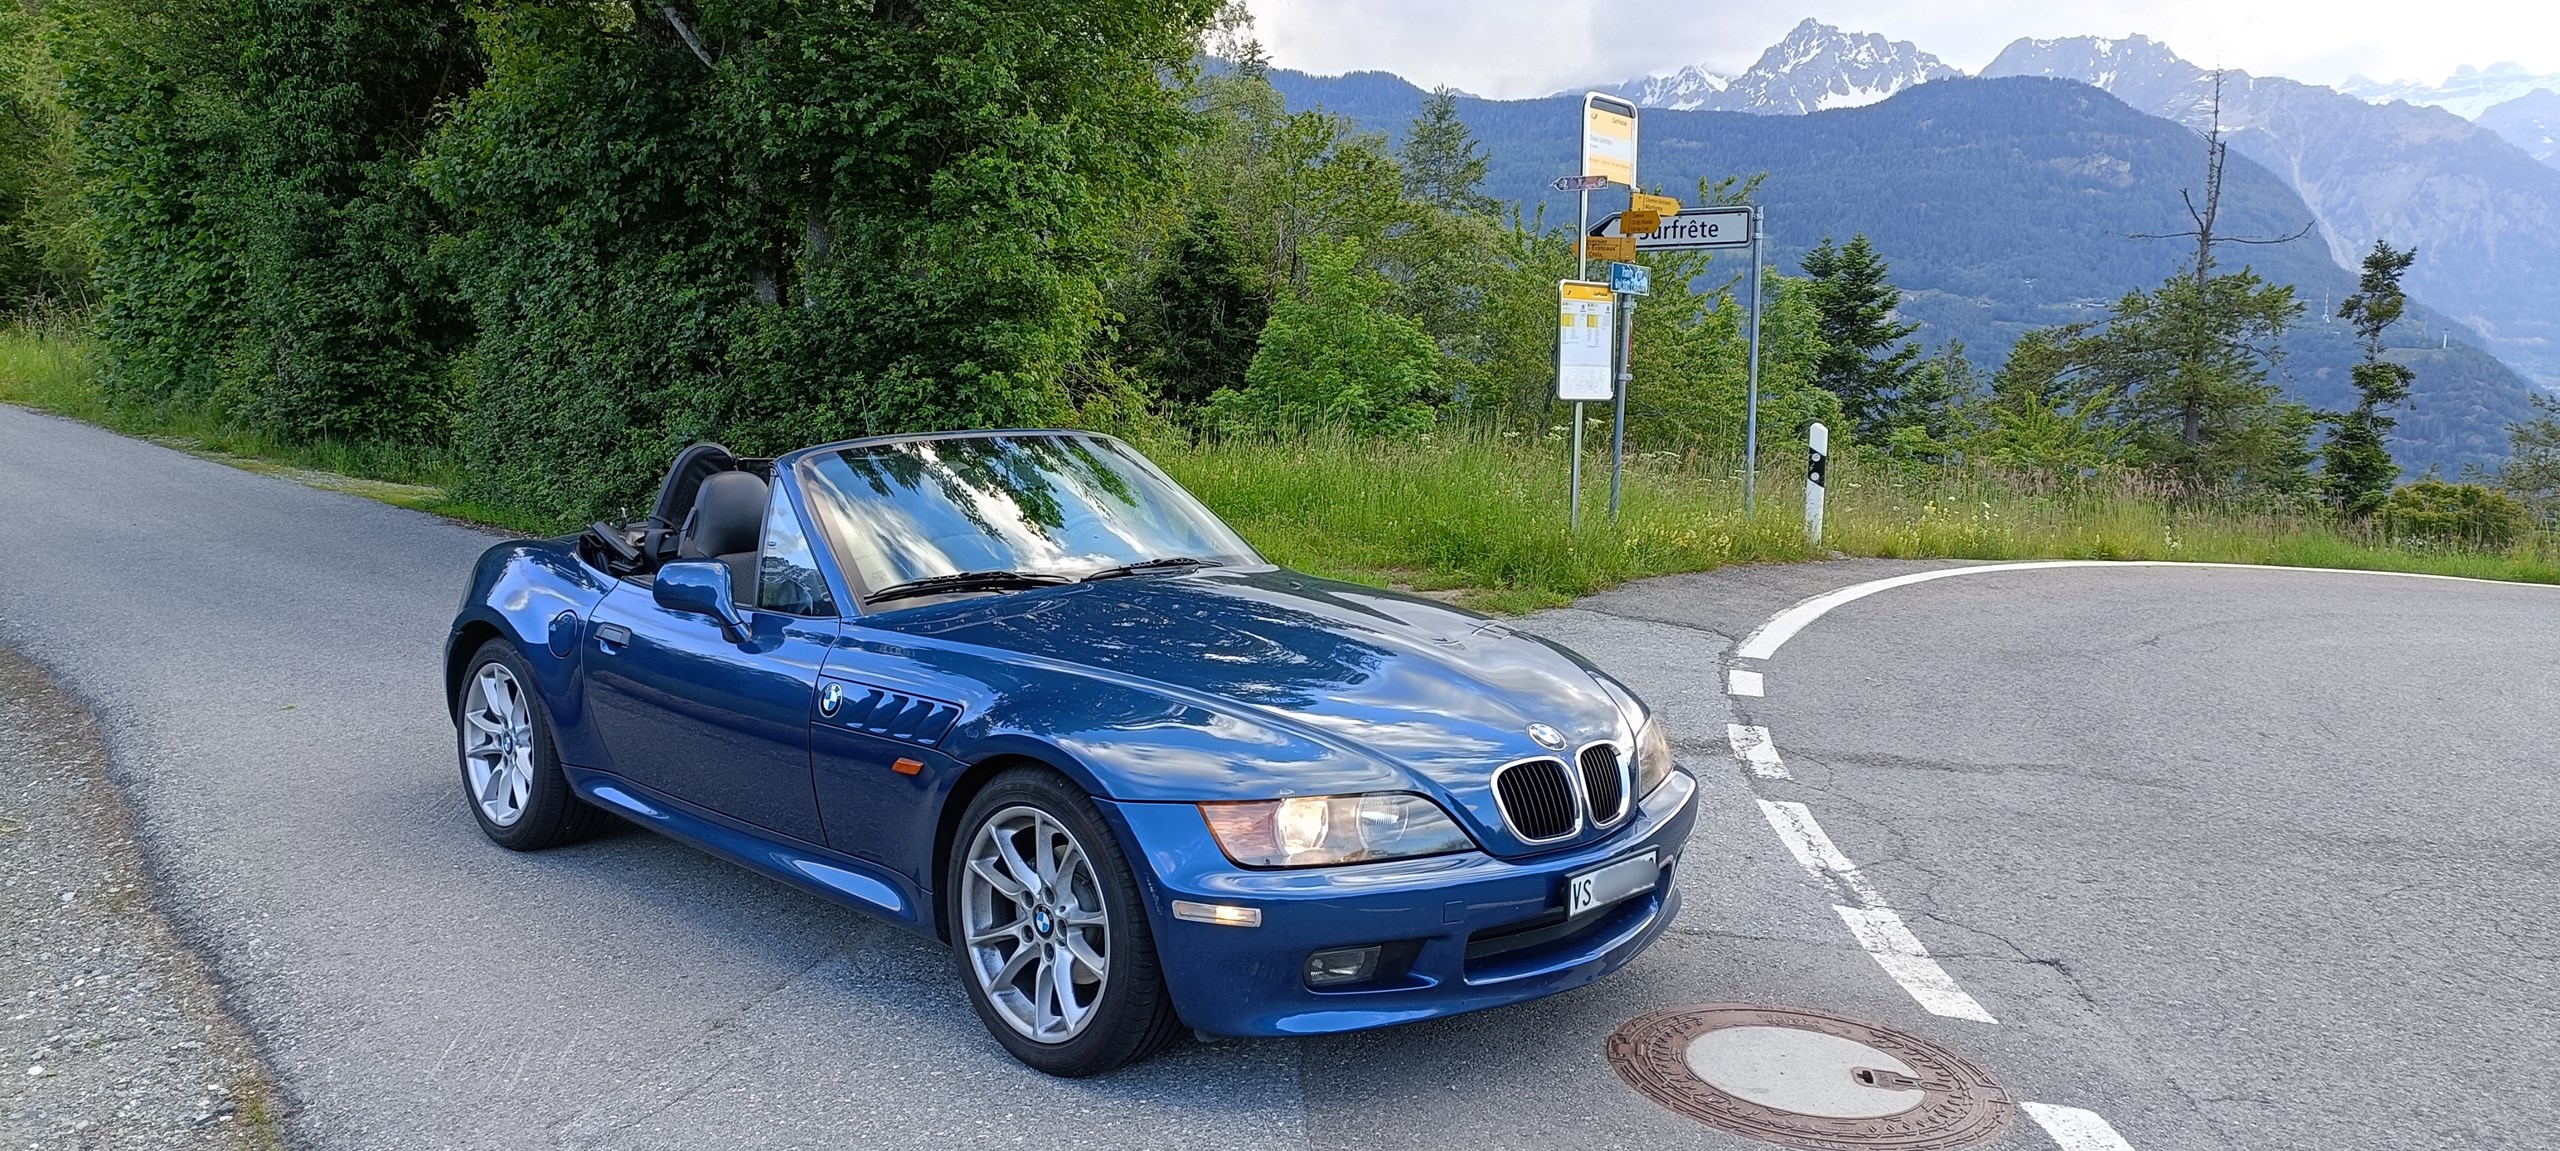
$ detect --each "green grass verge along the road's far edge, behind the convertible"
[0,327,2560,611]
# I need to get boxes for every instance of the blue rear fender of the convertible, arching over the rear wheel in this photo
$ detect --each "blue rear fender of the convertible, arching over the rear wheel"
[445,540,620,767]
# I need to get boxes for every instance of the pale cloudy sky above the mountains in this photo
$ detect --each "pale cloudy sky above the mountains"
[1247,0,2560,97]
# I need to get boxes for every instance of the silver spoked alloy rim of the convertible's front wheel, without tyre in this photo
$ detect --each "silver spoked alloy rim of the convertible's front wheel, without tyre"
[960,806,1111,1044]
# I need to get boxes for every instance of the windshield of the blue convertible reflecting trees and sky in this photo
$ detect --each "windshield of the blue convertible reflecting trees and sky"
[801,435,1260,591]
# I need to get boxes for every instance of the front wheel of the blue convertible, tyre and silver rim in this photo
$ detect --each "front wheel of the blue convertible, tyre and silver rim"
[945,770,1180,1079]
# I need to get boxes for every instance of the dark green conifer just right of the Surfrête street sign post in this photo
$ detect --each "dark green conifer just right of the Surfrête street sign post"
[1802,233,1920,442]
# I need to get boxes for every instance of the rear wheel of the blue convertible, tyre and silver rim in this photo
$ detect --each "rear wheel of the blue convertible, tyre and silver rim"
[453,639,607,852]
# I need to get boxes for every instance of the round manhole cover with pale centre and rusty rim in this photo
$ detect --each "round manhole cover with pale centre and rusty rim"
[1608,1003,2017,1151]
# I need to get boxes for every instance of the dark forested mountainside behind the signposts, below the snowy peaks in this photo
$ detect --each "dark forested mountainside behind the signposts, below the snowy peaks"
[1272,72,2529,473]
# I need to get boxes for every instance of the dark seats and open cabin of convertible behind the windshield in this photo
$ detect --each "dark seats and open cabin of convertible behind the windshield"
[579,442,773,596]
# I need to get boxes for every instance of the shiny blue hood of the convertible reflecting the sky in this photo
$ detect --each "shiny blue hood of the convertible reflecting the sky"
[870,568,1631,854]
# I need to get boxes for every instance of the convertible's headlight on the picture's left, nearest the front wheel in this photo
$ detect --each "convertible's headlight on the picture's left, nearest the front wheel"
[1201,793,1475,867]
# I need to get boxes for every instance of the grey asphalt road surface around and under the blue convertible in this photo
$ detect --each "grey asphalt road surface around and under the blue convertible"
[0,407,2560,1151]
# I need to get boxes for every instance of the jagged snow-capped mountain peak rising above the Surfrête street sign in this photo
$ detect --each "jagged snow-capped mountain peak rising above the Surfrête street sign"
[1613,18,1964,115]
